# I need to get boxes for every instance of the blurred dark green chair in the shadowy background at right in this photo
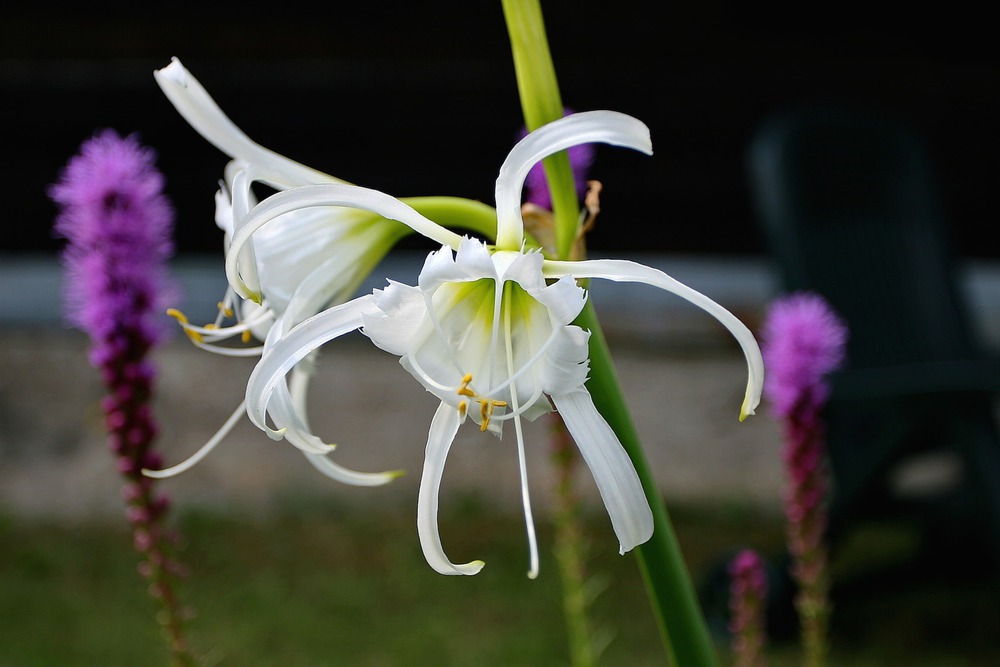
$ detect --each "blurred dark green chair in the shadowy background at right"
[747,108,1000,570]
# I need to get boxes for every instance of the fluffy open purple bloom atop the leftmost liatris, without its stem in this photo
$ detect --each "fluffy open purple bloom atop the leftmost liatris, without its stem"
[49,130,175,352]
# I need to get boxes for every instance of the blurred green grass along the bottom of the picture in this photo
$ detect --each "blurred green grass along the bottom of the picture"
[0,498,1000,667]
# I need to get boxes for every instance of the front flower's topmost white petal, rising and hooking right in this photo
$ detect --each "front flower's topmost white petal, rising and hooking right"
[496,111,653,250]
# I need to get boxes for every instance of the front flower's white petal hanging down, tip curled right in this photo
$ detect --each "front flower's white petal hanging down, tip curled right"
[417,403,485,575]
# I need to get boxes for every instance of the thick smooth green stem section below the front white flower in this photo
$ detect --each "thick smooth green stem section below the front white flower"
[577,301,717,667]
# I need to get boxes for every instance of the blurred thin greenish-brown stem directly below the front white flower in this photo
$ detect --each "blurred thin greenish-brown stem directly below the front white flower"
[552,413,598,667]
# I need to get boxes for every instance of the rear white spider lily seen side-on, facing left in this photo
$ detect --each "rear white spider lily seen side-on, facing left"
[146,58,409,486]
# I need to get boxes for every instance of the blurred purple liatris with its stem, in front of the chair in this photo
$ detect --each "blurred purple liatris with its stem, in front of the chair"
[762,292,848,667]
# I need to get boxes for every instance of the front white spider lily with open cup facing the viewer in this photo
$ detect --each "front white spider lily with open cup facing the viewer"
[236,111,763,577]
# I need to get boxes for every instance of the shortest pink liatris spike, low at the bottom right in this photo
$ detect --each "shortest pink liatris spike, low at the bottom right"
[729,549,768,667]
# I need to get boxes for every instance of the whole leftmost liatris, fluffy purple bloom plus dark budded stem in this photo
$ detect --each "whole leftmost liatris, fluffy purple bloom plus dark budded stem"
[50,130,195,666]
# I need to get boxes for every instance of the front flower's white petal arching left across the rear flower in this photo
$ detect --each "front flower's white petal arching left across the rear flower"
[226,183,462,301]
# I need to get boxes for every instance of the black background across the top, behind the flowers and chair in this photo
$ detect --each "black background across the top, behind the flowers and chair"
[0,0,1000,258]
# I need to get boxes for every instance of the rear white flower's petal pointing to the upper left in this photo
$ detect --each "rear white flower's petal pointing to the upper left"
[153,58,343,188]
